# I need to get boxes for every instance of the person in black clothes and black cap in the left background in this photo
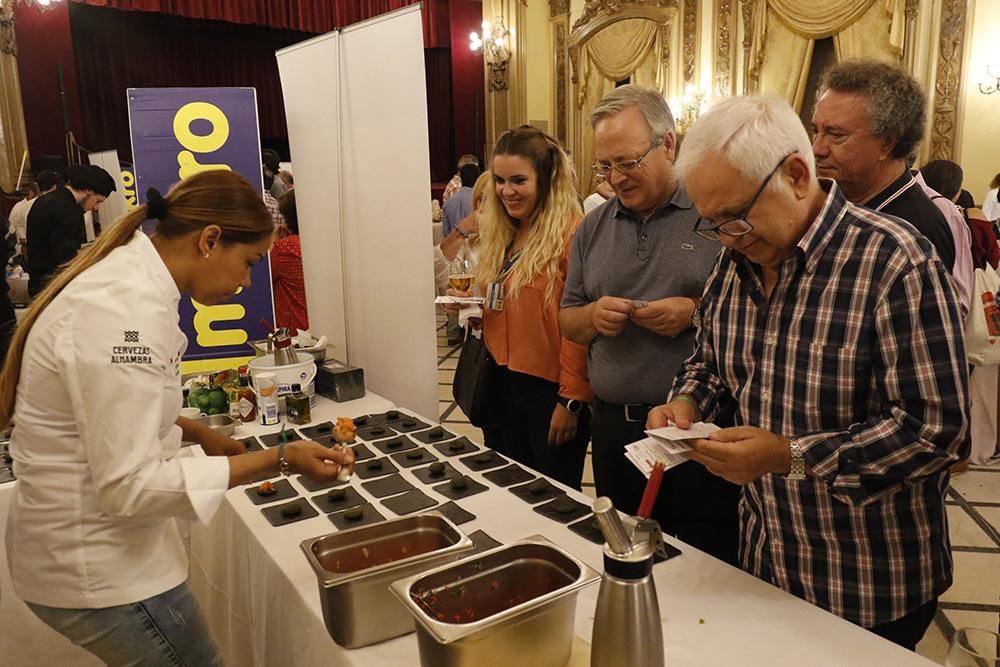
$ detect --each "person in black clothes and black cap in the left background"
[27,164,115,297]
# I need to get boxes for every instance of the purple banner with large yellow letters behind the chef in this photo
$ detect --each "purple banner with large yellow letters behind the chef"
[128,88,274,372]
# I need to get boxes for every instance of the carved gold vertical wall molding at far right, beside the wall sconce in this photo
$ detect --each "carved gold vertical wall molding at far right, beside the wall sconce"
[931,0,968,160]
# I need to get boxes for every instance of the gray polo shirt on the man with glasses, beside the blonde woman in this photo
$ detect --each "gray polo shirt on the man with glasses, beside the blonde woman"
[562,186,720,405]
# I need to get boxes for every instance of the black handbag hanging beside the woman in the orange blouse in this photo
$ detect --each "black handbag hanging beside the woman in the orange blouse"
[451,327,501,428]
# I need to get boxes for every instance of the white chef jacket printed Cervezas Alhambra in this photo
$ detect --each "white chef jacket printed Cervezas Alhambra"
[7,231,229,608]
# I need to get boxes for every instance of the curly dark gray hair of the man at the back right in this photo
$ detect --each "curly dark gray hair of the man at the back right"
[816,58,927,159]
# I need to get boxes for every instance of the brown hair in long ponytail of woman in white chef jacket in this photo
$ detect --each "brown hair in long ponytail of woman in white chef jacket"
[0,170,274,428]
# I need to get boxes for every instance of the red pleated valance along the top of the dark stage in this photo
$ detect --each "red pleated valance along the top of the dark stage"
[66,0,449,48]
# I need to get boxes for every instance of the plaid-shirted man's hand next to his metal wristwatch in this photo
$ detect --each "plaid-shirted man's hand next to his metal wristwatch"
[689,426,792,484]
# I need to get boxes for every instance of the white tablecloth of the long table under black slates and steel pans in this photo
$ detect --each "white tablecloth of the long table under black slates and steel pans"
[182,394,933,667]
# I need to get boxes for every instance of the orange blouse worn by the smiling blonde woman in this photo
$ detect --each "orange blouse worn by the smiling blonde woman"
[482,220,594,403]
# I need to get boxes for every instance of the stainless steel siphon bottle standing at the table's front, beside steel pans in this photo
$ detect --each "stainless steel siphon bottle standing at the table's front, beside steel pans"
[590,496,663,667]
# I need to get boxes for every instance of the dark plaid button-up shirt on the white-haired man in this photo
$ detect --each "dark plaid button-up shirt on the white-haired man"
[672,180,969,627]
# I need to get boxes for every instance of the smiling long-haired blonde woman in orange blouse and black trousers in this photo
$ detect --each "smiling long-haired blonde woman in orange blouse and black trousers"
[449,125,592,489]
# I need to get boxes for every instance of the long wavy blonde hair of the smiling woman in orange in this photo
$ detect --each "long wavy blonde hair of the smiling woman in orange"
[476,125,583,303]
